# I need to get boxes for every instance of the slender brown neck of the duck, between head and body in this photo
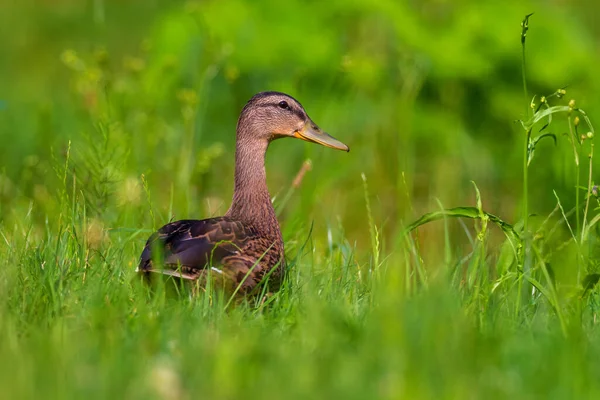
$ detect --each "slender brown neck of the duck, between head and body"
[226,137,276,226]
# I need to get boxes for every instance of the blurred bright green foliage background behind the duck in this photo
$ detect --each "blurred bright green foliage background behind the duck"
[0,0,600,250]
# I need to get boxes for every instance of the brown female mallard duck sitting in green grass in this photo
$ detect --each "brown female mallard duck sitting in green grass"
[139,92,349,293]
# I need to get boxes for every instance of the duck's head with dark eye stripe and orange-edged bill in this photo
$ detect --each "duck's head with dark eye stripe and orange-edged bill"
[238,92,350,151]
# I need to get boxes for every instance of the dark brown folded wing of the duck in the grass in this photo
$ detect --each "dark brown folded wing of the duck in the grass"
[139,217,253,279]
